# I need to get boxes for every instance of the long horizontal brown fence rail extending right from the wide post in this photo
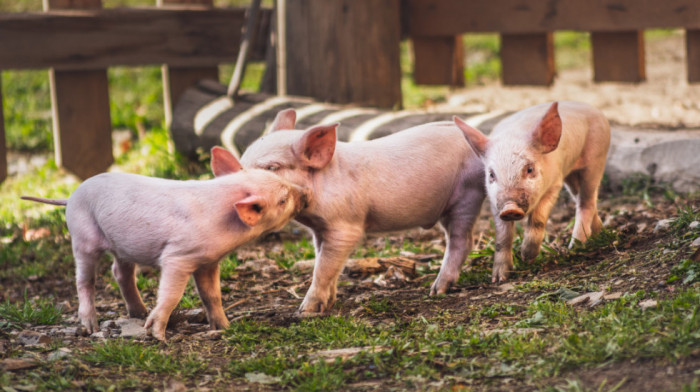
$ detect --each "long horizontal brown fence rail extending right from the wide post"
[402,0,700,37]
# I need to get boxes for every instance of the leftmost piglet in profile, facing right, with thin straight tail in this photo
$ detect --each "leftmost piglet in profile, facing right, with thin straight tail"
[22,147,306,341]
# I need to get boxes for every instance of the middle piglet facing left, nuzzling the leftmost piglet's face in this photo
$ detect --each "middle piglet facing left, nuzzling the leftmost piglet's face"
[241,109,485,316]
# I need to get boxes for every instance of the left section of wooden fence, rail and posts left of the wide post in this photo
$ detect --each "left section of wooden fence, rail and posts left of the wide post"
[0,0,270,181]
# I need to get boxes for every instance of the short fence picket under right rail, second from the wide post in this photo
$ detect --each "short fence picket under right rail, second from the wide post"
[501,33,554,86]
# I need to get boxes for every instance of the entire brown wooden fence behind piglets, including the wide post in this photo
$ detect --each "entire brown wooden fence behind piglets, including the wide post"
[0,0,700,180]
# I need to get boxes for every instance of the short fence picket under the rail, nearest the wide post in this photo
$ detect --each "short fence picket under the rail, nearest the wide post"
[412,35,464,86]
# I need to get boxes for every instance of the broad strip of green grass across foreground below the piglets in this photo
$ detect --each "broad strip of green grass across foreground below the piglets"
[221,291,700,390]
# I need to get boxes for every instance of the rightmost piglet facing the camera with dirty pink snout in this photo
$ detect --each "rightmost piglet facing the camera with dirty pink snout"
[454,101,610,282]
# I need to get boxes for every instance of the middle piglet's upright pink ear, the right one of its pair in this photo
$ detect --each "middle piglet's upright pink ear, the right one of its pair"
[292,123,339,169]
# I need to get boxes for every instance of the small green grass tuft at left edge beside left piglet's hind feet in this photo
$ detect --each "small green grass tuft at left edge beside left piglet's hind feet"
[0,295,63,325]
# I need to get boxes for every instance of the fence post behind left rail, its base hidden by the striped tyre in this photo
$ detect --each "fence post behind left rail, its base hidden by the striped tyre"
[156,0,219,126]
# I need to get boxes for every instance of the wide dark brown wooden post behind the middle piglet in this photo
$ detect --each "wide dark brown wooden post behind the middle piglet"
[285,0,401,107]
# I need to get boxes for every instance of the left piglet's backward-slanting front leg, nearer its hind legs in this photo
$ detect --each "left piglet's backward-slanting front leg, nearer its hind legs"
[144,262,193,342]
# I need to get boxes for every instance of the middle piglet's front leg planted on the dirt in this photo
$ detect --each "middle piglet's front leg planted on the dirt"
[297,224,364,317]
